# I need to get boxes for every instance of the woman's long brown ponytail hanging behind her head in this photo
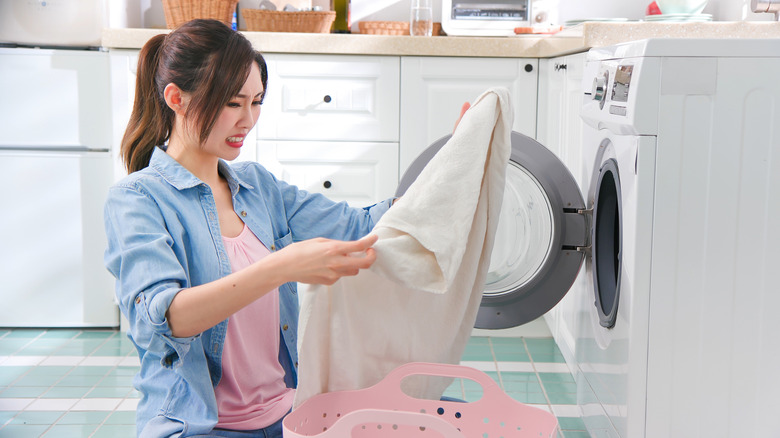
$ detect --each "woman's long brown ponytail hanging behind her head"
[121,35,174,173]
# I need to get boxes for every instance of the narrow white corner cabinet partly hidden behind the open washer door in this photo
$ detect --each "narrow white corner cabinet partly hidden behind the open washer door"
[537,53,589,363]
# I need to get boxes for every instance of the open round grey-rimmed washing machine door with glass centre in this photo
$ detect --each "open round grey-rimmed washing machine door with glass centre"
[396,132,588,329]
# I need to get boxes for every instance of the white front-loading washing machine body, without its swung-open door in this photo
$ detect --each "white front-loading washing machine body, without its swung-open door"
[569,39,780,438]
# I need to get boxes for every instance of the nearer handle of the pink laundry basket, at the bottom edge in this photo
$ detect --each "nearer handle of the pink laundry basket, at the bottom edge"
[327,409,465,438]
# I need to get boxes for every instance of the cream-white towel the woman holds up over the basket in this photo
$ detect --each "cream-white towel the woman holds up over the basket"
[294,88,513,407]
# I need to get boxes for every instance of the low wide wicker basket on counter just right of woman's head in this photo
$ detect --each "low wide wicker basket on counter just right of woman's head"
[241,9,336,33]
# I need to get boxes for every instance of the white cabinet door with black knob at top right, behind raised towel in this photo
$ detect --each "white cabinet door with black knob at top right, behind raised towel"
[399,57,538,173]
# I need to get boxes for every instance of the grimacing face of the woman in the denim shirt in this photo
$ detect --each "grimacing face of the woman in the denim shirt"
[203,62,265,161]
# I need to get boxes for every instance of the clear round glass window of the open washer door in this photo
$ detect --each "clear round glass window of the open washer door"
[484,162,555,295]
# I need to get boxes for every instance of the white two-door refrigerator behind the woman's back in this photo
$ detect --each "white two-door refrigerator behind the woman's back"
[0,48,119,327]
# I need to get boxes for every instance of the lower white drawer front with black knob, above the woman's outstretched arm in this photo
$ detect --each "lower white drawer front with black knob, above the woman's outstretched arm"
[258,140,398,207]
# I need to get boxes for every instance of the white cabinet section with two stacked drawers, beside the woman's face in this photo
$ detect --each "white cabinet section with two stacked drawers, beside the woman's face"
[256,53,400,207]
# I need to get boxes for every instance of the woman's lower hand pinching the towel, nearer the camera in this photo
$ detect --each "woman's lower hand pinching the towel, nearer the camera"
[274,234,378,285]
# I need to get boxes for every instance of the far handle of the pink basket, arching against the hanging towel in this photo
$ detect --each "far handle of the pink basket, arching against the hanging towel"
[375,362,505,403]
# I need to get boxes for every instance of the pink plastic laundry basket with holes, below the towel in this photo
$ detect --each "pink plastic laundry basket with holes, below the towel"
[282,362,558,438]
